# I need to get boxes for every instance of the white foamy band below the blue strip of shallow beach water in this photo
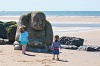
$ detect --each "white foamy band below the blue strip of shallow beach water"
[53,27,100,33]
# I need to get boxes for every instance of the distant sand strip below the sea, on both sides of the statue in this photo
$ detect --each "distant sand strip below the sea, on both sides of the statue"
[0,16,100,22]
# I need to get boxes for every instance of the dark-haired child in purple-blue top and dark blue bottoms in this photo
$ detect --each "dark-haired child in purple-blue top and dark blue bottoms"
[51,35,62,60]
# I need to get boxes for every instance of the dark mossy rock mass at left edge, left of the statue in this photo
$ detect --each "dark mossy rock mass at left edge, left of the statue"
[0,21,17,44]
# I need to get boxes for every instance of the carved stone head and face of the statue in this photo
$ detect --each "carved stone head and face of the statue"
[31,12,46,30]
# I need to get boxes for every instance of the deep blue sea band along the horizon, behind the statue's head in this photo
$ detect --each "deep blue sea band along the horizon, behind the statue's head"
[0,11,100,17]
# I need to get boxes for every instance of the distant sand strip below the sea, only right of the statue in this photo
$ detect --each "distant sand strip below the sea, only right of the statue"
[47,16,100,22]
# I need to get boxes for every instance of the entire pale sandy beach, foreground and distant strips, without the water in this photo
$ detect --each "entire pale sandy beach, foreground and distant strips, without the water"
[0,16,100,66]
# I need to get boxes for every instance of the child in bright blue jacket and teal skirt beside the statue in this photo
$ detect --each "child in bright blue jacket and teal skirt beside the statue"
[19,25,28,54]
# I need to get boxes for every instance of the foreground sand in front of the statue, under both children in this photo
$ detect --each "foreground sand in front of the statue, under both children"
[0,45,100,66]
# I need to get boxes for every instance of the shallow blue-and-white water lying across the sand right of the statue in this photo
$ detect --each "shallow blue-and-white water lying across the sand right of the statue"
[51,22,100,33]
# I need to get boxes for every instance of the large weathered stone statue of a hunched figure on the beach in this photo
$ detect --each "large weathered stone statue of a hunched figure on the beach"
[16,12,53,49]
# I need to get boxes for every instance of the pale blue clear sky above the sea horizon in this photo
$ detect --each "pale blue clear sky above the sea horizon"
[0,0,100,11]
